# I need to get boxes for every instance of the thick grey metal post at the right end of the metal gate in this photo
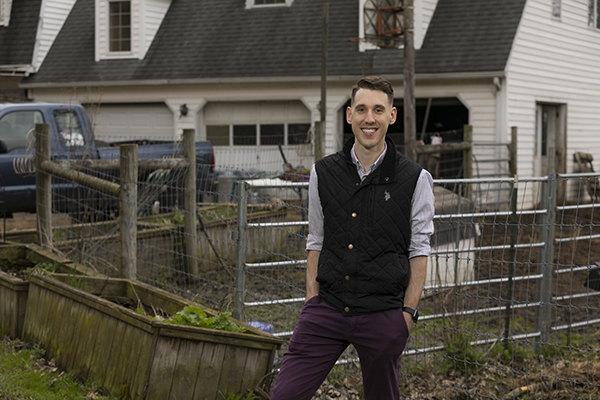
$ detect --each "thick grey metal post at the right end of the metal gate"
[536,173,556,347]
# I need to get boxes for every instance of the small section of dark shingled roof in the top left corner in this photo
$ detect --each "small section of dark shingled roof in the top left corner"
[0,0,42,67]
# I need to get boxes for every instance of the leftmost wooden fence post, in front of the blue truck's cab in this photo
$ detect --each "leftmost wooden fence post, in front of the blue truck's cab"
[35,124,52,250]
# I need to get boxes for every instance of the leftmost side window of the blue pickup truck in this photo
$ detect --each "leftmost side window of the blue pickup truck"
[0,111,44,151]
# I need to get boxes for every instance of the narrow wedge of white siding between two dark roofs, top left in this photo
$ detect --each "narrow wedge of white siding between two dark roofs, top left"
[33,0,76,72]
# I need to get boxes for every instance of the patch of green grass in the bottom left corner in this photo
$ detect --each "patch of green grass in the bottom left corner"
[0,338,117,400]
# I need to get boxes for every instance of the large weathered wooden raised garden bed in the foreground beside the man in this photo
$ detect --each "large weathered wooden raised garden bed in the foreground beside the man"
[24,274,282,400]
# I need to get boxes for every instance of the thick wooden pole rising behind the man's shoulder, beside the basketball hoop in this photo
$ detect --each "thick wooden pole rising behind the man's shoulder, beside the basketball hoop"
[404,0,417,161]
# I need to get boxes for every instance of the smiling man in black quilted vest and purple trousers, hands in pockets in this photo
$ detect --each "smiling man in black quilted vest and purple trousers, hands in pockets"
[271,76,434,400]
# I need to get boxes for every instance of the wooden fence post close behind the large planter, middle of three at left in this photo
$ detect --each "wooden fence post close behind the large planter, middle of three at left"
[119,144,138,279]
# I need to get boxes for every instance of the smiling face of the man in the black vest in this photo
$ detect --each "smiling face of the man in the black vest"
[346,89,397,152]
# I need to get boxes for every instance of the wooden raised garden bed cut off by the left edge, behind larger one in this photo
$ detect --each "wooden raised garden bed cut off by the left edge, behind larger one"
[0,244,95,338]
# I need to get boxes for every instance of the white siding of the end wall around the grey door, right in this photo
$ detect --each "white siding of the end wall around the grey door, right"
[506,0,600,182]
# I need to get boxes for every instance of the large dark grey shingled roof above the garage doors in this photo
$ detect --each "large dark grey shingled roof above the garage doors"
[24,0,526,87]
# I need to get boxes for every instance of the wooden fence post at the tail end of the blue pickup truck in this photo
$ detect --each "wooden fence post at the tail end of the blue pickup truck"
[183,129,199,277]
